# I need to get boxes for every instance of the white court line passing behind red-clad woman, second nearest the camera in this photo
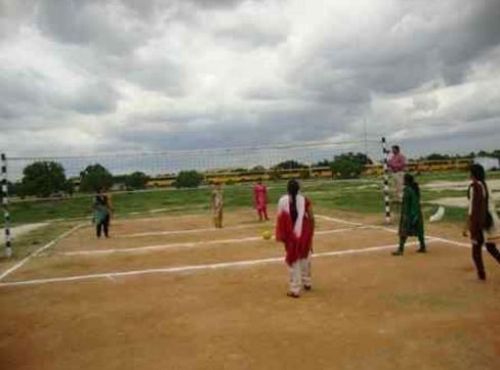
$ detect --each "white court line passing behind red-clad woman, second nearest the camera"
[57,226,370,256]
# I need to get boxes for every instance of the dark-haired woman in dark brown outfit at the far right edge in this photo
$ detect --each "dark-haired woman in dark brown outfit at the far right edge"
[464,164,500,280]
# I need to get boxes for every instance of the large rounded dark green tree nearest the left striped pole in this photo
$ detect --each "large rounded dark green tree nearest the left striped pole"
[22,161,66,197]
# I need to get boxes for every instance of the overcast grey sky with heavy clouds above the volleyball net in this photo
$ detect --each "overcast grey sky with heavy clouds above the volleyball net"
[0,0,500,159]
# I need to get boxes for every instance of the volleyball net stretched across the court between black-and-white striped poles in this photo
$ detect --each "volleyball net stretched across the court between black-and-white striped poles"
[1,139,385,255]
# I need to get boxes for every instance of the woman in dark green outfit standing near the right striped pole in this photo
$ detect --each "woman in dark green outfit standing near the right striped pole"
[392,173,427,256]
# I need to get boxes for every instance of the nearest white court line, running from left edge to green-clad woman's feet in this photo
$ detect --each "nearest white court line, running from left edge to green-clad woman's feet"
[0,238,430,288]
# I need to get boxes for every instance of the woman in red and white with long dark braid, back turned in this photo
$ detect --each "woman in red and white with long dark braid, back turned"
[276,180,314,298]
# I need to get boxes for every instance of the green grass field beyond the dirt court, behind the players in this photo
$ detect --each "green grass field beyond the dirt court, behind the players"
[4,172,484,224]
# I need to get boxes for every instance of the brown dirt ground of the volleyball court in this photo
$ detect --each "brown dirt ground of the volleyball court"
[0,210,500,370]
